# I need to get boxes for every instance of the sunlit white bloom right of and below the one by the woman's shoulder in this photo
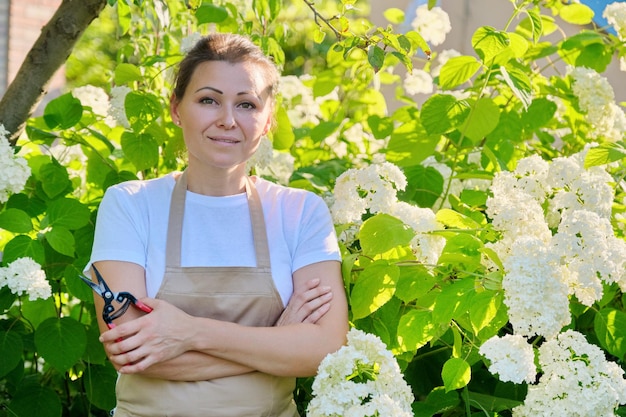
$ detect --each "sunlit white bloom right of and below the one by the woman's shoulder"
[389,201,446,265]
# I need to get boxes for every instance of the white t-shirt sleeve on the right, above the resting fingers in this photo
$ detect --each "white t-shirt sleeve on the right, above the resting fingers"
[293,193,341,272]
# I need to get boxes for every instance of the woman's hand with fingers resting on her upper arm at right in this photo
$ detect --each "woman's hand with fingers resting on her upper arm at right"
[275,278,333,326]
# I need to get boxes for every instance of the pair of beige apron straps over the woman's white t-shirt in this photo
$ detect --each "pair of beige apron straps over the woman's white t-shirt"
[165,170,270,268]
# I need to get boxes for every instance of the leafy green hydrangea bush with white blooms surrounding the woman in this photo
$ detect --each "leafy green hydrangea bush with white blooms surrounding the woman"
[0,0,626,417]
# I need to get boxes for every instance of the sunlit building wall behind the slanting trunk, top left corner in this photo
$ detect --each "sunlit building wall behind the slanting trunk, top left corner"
[0,0,65,98]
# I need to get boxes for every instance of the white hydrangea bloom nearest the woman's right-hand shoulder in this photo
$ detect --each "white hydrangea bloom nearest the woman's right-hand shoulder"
[331,162,407,224]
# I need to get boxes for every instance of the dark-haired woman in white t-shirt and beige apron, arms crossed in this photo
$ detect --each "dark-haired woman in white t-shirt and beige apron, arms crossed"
[91,34,348,417]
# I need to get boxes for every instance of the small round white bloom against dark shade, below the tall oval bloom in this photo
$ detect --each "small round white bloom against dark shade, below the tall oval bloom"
[479,334,537,384]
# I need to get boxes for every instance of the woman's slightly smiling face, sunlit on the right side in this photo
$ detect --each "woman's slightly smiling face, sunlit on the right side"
[171,61,272,170]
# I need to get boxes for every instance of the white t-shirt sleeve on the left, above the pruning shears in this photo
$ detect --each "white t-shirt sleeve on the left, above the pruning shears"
[86,186,147,268]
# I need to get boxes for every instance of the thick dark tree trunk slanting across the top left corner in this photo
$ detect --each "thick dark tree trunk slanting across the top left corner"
[0,0,107,145]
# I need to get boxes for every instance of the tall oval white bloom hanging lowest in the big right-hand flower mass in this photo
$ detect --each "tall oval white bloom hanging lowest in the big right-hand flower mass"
[502,235,571,337]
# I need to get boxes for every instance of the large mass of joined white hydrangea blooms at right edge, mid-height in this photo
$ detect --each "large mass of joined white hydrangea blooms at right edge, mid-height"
[486,150,626,337]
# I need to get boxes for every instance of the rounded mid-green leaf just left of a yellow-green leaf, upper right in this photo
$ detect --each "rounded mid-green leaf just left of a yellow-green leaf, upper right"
[420,94,467,135]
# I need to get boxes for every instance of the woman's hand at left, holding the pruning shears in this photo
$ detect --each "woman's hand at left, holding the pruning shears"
[100,298,193,373]
